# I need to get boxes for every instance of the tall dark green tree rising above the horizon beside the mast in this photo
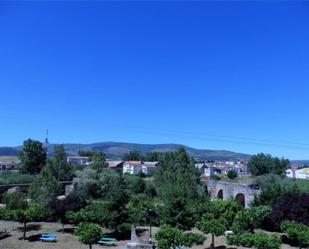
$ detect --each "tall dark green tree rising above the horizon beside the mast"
[19,139,47,174]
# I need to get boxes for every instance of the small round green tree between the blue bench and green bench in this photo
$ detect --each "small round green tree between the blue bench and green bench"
[75,223,102,249]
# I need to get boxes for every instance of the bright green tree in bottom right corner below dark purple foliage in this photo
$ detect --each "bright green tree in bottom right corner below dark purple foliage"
[281,221,309,249]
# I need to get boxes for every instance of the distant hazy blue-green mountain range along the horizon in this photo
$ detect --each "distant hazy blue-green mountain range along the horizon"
[0,142,250,161]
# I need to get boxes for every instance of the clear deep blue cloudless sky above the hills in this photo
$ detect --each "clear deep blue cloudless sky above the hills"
[0,1,309,159]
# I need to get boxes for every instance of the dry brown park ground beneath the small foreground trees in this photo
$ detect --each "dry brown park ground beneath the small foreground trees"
[0,221,297,249]
